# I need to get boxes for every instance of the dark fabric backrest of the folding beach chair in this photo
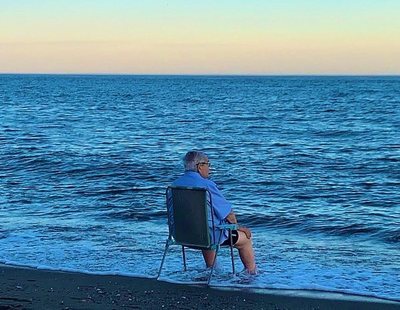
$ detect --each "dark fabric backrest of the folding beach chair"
[166,186,213,248]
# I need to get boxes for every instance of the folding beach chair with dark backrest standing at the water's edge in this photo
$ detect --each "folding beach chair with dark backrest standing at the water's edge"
[157,186,237,285]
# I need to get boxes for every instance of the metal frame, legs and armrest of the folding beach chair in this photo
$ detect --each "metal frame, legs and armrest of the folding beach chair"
[157,186,238,285]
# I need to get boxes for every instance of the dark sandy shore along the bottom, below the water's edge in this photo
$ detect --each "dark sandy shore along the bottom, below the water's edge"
[0,265,400,310]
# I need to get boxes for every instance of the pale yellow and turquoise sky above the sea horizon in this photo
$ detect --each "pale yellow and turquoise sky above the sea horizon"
[0,0,400,75]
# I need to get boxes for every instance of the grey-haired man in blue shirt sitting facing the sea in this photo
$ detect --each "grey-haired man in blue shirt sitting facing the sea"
[172,151,256,274]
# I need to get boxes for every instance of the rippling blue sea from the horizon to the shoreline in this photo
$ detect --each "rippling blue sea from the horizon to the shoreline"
[0,75,400,300]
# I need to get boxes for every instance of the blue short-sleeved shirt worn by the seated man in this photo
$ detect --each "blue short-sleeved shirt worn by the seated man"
[172,171,232,243]
